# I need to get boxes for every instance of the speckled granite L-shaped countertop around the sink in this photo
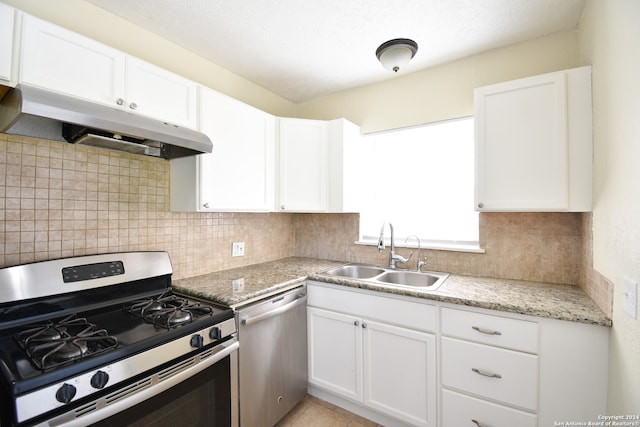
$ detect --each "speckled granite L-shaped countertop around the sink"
[173,258,612,326]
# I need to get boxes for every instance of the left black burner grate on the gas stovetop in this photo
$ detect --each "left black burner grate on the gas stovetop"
[15,314,118,371]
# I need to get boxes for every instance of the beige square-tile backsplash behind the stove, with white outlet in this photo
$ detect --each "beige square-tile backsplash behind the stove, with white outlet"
[0,134,295,278]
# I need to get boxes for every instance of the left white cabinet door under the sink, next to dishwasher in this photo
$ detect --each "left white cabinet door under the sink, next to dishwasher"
[307,307,362,402]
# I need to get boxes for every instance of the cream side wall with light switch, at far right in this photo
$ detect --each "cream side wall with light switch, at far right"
[579,0,640,415]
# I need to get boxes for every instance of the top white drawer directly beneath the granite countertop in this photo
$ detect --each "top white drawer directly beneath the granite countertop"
[442,308,538,353]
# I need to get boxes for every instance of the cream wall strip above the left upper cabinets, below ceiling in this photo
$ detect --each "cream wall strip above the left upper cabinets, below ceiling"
[2,0,294,117]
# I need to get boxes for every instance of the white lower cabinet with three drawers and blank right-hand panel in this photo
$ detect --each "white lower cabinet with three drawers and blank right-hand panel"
[439,306,609,427]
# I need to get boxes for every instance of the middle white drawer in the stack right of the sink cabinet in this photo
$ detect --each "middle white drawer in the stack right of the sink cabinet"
[441,337,538,411]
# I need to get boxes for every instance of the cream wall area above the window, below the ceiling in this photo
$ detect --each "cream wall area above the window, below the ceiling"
[296,31,582,133]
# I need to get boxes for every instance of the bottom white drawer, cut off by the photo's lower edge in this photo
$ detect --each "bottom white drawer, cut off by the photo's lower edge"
[442,390,537,427]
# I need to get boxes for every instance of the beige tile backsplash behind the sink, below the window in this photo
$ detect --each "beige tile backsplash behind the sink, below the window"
[294,213,583,284]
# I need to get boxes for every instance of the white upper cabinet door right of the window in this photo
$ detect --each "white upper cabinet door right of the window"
[475,72,569,211]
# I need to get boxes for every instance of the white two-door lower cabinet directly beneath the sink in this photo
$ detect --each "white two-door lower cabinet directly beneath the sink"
[307,283,437,427]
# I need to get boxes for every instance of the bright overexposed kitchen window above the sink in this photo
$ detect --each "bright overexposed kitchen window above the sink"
[360,117,479,251]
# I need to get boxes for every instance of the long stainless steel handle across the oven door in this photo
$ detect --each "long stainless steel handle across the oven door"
[44,337,240,427]
